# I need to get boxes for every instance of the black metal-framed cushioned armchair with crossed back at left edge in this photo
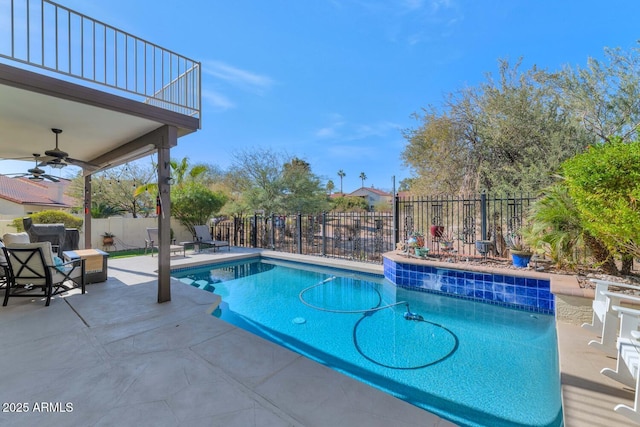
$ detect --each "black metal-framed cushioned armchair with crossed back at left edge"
[2,242,85,306]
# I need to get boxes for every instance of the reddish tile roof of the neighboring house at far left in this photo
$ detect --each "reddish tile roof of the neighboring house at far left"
[0,175,77,208]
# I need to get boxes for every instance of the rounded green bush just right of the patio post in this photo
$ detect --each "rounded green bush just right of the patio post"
[171,181,227,236]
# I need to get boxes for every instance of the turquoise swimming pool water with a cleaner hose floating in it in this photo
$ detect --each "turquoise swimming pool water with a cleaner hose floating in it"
[172,260,562,427]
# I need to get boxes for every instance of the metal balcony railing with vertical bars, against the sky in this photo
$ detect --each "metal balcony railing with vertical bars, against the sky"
[0,0,201,118]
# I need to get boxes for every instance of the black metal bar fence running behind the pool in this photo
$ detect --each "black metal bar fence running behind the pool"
[212,194,535,263]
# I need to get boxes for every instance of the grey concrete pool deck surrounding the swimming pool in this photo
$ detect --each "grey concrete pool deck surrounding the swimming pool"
[0,248,634,427]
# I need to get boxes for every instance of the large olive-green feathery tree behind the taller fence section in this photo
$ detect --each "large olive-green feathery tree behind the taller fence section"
[402,61,593,193]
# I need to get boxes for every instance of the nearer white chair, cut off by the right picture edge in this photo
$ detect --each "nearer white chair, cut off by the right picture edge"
[600,306,640,423]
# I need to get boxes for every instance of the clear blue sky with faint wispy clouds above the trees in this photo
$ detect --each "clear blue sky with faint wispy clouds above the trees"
[1,0,640,193]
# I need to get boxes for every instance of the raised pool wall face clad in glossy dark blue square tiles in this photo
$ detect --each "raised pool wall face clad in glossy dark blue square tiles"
[383,258,555,314]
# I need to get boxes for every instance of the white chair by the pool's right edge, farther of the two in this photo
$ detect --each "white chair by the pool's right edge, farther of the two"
[582,279,640,356]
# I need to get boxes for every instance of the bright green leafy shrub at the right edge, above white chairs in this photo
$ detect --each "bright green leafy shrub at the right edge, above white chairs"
[562,137,640,262]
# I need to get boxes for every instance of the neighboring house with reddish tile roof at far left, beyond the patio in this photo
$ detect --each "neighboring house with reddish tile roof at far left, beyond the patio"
[0,175,80,217]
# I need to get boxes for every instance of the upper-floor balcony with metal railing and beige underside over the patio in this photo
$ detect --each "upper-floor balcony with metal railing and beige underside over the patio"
[0,0,201,172]
